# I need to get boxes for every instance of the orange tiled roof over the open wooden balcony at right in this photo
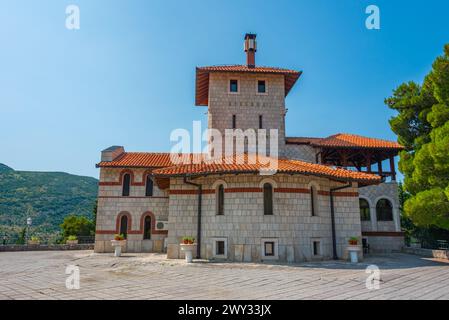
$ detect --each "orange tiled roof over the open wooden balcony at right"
[286,133,404,150]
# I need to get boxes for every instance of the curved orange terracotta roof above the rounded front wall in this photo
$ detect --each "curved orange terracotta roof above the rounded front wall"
[153,155,381,185]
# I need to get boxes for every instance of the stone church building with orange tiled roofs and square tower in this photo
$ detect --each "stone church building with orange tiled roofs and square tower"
[95,34,404,262]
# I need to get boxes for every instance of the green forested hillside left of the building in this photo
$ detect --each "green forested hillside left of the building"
[0,163,98,239]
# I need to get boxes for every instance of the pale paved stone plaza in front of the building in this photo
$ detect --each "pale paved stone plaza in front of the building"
[0,251,449,300]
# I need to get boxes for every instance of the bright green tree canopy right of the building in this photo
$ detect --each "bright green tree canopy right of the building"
[385,44,449,230]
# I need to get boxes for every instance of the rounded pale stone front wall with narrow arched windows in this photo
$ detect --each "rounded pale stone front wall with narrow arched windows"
[168,175,361,262]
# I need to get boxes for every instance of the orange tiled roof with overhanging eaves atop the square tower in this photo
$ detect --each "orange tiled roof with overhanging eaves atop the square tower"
[195,65,302,106]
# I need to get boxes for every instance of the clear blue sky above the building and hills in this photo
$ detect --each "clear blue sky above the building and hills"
[0,0,449,177]
